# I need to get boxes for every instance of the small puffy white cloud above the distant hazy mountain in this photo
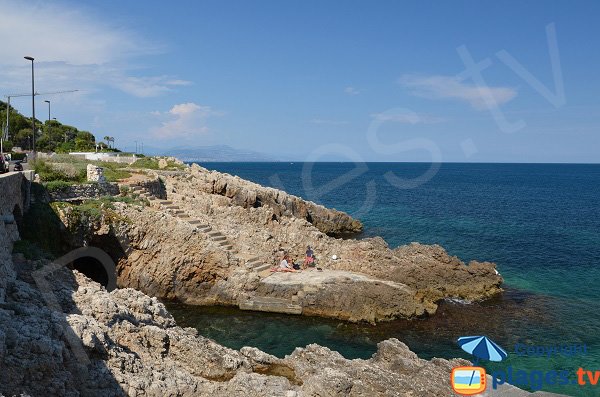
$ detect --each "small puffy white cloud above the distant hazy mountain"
[152,102,222,139]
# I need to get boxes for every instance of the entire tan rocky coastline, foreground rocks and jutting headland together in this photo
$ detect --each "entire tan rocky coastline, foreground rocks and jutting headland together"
[0,164,568,397]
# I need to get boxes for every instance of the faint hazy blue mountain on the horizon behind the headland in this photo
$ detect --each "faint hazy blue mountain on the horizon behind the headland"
[144,145,279,162]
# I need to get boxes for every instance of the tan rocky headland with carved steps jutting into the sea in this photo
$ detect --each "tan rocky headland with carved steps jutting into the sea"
[97,162,502,322]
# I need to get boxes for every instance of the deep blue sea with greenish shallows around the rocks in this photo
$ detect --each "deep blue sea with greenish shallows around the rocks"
[168,162,600,396]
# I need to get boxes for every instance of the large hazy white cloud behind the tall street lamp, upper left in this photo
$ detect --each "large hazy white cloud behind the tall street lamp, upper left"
[0,0,191,98]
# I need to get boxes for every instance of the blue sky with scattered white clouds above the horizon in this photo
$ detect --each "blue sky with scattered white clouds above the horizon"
[0,0,600,163]
